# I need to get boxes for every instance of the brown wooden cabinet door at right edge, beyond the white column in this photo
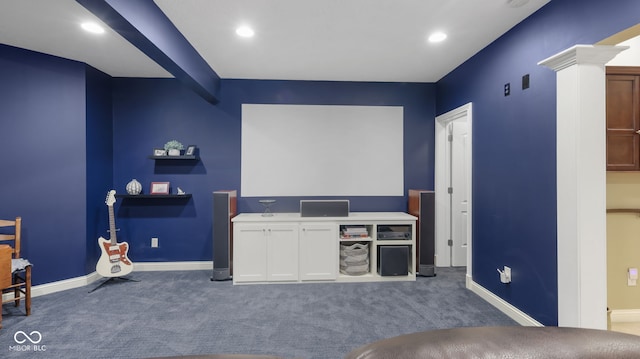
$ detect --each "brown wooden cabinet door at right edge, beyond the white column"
[606,75,640,171]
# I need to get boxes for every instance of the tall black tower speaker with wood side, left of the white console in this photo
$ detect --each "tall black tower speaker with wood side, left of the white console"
[211,190,238,280]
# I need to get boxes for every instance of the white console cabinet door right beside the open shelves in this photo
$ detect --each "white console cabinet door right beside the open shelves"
[299,224,339,280]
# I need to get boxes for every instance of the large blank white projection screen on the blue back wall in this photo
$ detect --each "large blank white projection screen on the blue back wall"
[240,104,404,197]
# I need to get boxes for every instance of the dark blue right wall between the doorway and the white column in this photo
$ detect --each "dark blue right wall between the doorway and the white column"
[437,0,640,325]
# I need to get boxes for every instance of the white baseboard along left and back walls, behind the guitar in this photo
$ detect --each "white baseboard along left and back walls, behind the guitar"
[2,261,213,299]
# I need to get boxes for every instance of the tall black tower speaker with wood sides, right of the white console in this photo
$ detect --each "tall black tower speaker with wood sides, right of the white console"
[409,189,436,277]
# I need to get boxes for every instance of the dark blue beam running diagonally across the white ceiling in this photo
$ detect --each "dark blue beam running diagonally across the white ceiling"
[76,0,220,104]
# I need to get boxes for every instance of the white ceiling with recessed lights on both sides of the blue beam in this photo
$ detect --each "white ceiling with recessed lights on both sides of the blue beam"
[0,0,549,82]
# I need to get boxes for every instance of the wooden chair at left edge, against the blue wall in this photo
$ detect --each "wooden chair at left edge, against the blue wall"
[0,217,31,328]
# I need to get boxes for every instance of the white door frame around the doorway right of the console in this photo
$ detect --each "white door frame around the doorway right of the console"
[434,102,473,287]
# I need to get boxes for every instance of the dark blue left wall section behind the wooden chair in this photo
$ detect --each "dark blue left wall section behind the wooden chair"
[0,45,87,285]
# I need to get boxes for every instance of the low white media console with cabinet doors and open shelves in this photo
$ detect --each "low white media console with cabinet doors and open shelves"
[231,212,417,284]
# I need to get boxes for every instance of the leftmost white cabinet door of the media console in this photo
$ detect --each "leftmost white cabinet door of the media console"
[233,224,267,282]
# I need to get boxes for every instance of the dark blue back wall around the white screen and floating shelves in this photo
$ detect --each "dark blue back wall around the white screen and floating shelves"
[113,79,435,261]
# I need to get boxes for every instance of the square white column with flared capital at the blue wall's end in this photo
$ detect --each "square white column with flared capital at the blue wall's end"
[538,45,626,329]
